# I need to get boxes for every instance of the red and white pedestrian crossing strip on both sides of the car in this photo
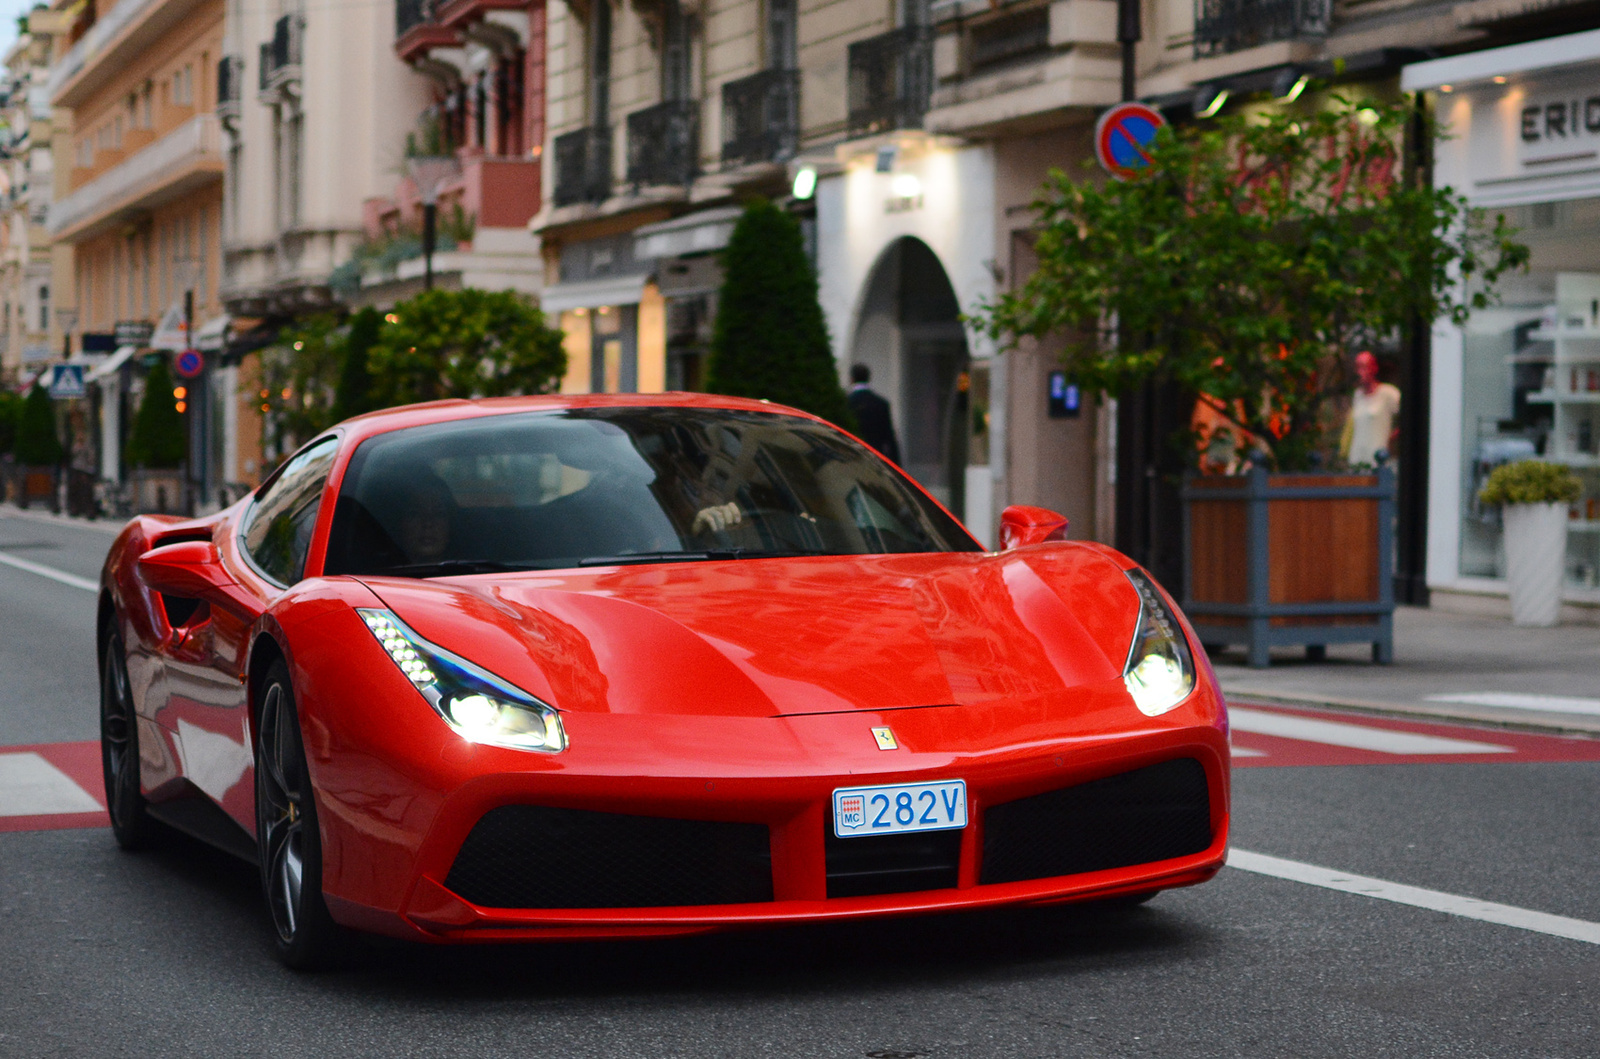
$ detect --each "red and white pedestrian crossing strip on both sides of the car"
[0,702,1600,832]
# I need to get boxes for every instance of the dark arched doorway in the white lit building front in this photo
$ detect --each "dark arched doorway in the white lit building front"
[850,235,970,515]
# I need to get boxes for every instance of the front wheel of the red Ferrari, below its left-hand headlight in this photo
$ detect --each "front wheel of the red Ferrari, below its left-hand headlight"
[256,659,342,971]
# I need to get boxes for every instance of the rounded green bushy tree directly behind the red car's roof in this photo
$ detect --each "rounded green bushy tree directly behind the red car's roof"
[366,288,566,408]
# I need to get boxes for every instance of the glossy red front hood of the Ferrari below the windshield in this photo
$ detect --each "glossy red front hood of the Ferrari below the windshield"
[363,544,1139,717]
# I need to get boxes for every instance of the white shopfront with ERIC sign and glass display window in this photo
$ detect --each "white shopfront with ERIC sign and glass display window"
[1403,29,1600,622]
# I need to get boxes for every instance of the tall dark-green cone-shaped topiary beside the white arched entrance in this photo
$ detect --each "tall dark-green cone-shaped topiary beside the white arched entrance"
[706,198,854,427]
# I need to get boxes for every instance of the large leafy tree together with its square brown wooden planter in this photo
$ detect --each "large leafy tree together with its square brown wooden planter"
[979,93,1528,665]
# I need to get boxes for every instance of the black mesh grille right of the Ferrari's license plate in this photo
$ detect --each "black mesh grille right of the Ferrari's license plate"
[981,758,1211,883]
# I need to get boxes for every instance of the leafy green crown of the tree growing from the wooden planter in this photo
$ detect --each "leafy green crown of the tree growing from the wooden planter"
[979,96,1528,470]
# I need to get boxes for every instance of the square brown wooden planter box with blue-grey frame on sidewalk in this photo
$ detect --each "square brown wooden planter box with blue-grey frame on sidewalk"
[1182,467,1395,669]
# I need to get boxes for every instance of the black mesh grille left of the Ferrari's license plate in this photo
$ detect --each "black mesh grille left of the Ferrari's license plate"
[445,805,773,909]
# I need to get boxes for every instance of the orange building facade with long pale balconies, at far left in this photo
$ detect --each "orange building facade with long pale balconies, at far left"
[48,0,224,492]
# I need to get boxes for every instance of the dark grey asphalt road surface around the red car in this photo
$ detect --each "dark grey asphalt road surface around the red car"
[0,517,1600,1059]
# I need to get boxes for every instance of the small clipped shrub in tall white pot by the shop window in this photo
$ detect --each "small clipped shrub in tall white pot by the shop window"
[1478,459,1584,625]
